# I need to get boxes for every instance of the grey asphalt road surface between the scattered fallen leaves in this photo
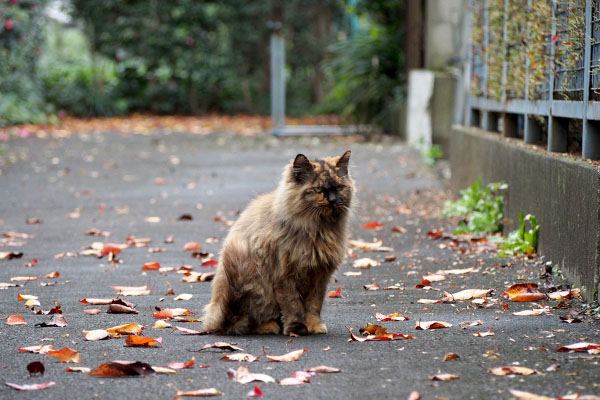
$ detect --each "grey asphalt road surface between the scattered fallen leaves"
[0,130,600,399]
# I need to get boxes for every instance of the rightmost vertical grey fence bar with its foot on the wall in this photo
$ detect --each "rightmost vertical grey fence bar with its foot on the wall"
[582,0,600,160]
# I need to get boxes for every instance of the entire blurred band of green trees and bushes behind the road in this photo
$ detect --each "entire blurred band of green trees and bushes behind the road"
[0,0,406,127]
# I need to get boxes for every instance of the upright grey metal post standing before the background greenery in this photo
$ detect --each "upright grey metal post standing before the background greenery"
[271,33,285,132]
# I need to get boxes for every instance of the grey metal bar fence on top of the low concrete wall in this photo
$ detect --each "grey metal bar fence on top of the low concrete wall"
[465,0,600,159]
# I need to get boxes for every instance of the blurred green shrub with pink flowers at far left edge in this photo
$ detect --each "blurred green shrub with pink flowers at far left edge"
[0,0,49,126]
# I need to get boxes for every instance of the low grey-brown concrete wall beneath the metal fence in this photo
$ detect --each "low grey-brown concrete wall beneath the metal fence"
[450,127,600,301]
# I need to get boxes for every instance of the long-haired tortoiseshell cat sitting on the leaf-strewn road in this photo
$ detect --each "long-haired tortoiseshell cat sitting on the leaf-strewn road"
[203,150,354,335]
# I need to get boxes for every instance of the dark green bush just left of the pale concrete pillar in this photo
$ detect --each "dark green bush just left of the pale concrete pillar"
[326,0,406,130]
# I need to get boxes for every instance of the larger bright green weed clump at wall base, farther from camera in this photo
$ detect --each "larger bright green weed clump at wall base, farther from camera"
[442,181,508,235]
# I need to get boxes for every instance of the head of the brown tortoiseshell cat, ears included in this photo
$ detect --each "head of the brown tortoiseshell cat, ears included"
[290,150,354,216]
